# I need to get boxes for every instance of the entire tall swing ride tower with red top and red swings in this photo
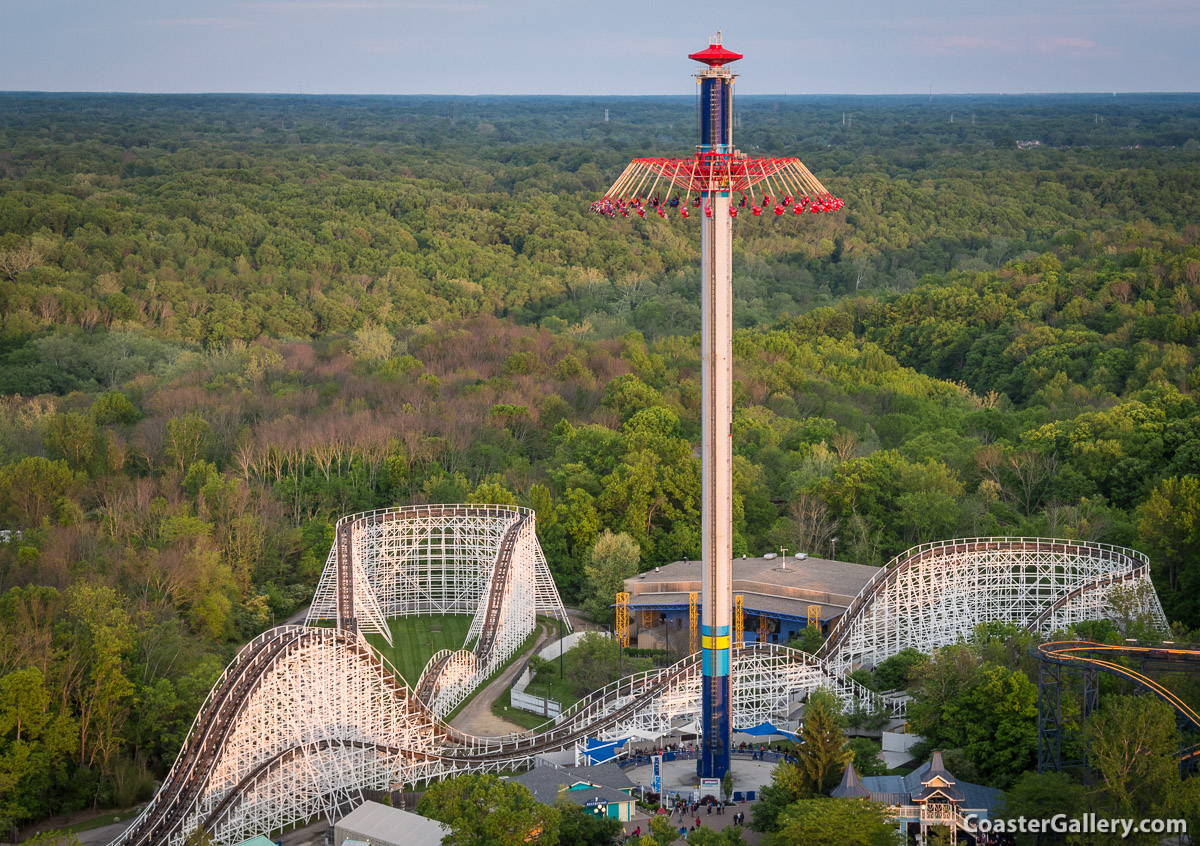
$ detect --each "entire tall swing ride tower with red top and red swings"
[592,32,842,779]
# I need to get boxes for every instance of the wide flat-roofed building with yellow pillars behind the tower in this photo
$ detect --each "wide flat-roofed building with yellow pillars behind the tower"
[625,553,877,650]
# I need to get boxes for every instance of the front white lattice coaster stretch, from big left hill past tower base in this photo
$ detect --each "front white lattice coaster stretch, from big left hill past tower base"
[113,626,881,846]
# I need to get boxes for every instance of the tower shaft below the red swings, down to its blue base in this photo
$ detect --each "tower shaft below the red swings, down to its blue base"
[698,192,733,779]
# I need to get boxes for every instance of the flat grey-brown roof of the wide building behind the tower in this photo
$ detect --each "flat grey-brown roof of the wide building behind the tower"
[625,556,877,613]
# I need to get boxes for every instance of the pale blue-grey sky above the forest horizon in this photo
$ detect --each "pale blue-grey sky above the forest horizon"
[0,0,1200,95]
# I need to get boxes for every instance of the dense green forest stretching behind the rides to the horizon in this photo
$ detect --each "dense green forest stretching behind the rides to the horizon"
[0,94,1200,823]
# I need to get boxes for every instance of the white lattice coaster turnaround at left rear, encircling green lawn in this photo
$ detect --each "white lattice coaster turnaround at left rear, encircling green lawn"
[306,505,570,715]
